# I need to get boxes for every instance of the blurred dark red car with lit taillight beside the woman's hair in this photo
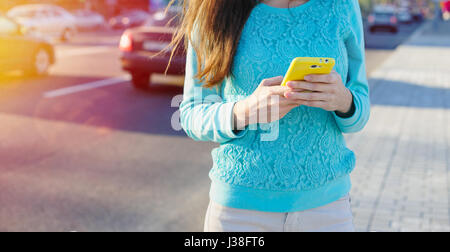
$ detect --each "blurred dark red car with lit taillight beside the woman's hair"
[119,8,186,89]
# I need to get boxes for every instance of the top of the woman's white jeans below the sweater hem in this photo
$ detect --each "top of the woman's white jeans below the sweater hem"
[204,195,355,232]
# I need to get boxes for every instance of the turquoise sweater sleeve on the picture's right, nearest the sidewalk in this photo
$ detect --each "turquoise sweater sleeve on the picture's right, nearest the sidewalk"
[334,0,370,133]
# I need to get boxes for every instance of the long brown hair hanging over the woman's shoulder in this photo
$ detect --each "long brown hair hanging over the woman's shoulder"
[166,0,260,88]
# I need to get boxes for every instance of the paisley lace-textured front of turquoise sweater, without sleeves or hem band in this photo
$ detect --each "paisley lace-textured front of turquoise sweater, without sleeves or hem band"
[210,0,355,192]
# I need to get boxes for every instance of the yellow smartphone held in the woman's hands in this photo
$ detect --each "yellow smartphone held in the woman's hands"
[281,57,336,86]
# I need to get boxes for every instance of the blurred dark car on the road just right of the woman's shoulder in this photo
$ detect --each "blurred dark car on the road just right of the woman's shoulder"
[367,10,398,33]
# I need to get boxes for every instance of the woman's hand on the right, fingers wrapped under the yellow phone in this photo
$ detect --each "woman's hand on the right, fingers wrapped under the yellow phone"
[285,71,353,114]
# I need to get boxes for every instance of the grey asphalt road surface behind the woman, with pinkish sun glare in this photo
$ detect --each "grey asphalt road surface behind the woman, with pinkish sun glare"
[0,22,422,231]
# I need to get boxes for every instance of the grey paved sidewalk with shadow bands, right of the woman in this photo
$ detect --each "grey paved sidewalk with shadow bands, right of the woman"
[347,23,450,231]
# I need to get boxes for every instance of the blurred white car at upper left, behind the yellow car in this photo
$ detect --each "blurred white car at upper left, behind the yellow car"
[7,4,76,41]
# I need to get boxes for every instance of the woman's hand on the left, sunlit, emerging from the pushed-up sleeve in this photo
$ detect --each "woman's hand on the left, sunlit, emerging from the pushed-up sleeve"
[233,76,299,130]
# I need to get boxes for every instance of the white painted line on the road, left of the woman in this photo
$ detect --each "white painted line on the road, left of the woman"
[44,76,130,99]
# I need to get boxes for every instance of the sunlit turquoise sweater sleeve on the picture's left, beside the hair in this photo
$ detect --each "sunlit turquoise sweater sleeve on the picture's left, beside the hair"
[180,40,246,144]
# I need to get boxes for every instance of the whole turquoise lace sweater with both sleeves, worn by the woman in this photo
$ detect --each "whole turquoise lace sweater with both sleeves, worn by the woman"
[180,0,370,212]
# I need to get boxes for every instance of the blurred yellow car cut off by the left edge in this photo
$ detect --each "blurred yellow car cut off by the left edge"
[0,15,55,76]
